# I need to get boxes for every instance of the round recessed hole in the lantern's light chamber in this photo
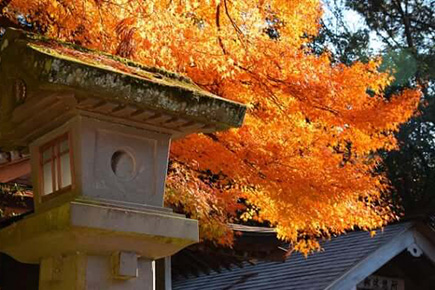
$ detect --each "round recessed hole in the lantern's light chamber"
[110,149,136,180]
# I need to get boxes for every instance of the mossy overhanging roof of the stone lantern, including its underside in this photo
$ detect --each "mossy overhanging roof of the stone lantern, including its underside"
[0,29,246,147]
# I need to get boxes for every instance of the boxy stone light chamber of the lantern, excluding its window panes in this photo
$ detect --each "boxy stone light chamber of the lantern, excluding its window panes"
[30,116,174,212]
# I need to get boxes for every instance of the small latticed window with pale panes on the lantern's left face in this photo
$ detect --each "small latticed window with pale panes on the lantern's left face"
[40,133,73,199]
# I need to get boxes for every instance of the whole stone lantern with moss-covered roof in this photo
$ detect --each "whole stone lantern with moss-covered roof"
[0,29,245,290]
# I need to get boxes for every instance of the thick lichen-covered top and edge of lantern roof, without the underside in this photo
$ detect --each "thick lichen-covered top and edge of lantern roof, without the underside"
[0,28,246,131]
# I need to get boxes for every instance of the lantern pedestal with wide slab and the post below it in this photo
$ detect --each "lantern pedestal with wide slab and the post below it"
[0,201,198,290]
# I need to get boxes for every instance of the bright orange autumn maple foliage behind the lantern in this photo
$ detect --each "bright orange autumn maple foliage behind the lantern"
[3,0,419,253]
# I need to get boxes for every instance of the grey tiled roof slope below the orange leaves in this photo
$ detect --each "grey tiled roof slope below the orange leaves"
[172,223,412,290]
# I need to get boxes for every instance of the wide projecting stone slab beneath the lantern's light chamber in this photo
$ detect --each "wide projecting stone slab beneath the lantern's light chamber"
[0,202,199,263]
